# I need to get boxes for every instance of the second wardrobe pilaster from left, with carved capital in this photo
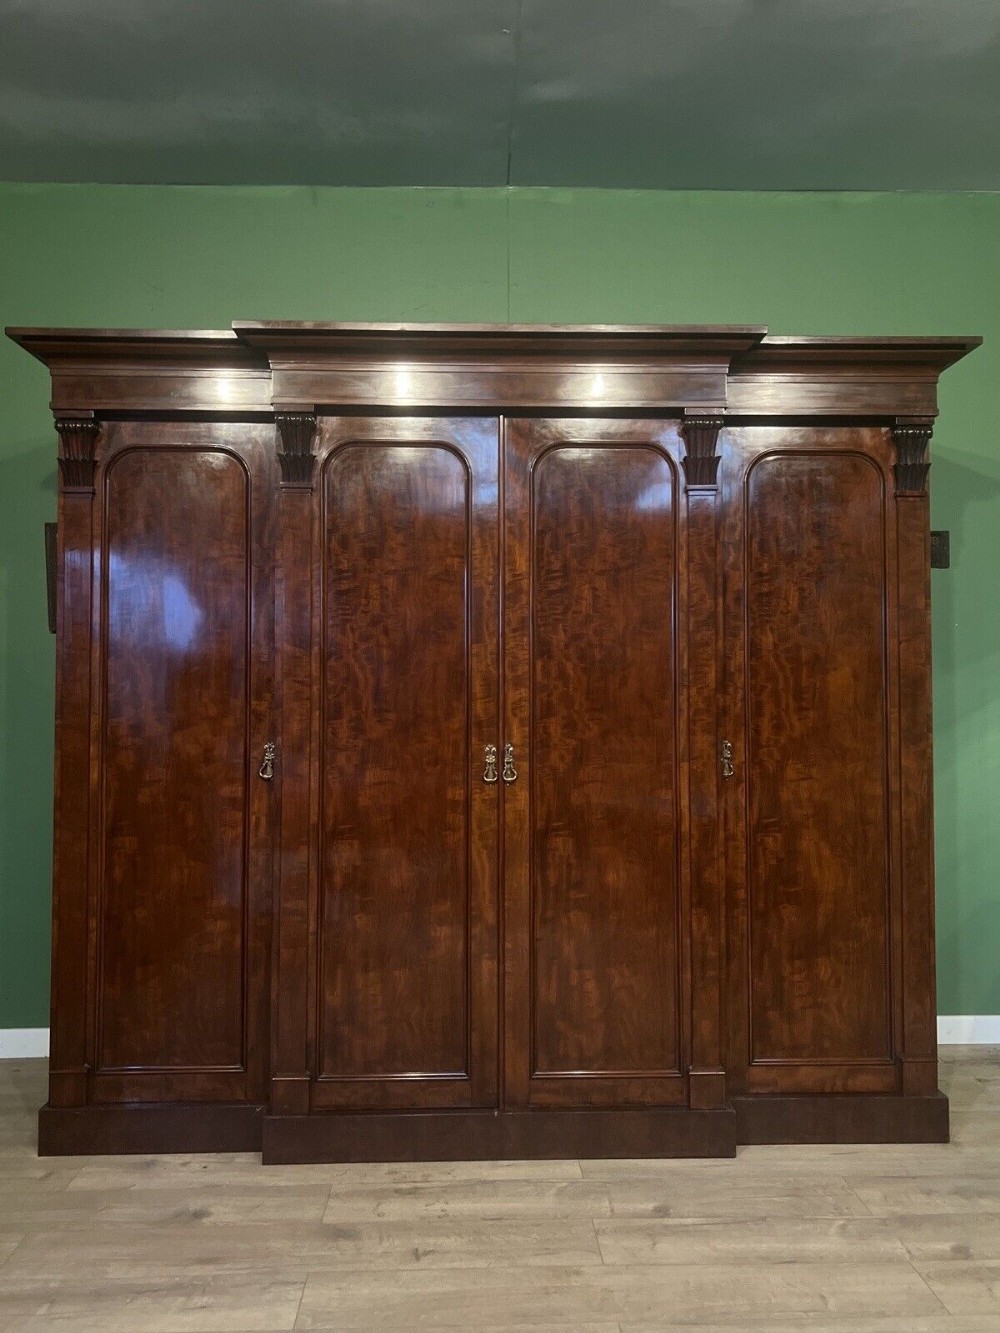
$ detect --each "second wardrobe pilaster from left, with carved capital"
[271,412,316,1116]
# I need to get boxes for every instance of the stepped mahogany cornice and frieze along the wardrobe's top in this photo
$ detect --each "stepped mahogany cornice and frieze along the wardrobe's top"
[7,320,983,417]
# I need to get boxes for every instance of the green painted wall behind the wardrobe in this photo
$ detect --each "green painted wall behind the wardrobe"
[0,185,1000,1026]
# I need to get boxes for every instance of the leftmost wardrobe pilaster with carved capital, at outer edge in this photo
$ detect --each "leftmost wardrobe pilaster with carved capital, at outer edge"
[49,413,100,1106]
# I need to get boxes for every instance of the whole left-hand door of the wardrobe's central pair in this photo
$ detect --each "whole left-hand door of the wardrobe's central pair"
[311,417,499,1110]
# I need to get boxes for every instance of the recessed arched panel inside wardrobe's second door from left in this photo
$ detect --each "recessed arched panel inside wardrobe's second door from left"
[317,443,475,1078]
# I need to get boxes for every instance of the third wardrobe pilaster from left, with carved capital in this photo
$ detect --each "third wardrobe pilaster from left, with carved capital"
[680,415,725,1108]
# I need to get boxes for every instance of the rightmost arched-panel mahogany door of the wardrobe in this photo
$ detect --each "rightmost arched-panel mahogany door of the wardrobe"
[723,427,900,1093]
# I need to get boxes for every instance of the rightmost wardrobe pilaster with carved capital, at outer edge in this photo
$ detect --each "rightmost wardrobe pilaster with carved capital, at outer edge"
[892,417,937,1093]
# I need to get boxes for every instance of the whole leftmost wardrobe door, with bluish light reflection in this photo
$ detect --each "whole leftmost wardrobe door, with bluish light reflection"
[90,423,275,1102]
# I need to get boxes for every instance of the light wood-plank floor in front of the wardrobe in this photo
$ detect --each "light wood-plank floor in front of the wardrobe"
[0,1046,1000,1333]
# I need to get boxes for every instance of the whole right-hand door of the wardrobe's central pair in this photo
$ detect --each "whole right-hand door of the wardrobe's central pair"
[501,420,685,1106]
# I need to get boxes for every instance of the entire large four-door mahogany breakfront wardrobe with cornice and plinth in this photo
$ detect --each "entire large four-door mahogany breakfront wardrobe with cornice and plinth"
[8,323,979,1161]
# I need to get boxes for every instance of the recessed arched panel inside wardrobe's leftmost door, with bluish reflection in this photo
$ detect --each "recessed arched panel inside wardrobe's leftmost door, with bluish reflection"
[97,448,251,1073]
